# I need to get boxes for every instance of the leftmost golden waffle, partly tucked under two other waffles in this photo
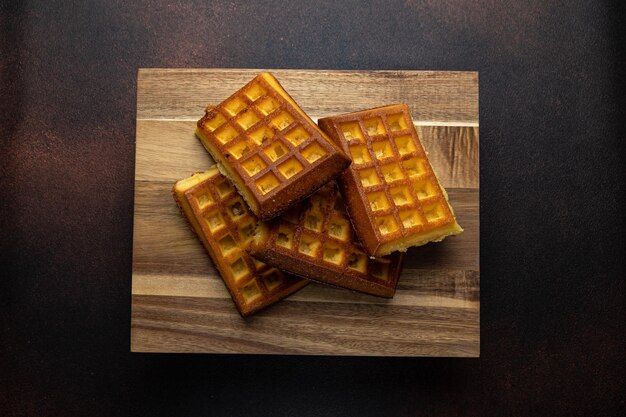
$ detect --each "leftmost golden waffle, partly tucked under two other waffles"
[172,167,307,317]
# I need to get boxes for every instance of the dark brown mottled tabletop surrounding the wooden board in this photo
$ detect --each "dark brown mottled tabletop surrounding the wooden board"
[0,0,626,416]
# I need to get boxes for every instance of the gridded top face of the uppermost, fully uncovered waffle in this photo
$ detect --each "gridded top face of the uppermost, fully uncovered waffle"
[201,76,334,202]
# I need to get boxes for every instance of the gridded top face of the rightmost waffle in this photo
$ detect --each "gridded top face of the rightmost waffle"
[334,108,454,241]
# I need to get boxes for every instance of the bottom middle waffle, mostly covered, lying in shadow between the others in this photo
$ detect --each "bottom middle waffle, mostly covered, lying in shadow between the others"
[249,181,404,297]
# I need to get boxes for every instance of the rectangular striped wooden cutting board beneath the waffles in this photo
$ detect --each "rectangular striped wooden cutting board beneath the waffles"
[131,69,480,357]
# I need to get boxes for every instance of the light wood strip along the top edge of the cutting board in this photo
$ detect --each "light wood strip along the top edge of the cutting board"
[137,69,478,122]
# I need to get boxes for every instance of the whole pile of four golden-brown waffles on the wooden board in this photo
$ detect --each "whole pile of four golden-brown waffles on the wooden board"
[173,73,462,316]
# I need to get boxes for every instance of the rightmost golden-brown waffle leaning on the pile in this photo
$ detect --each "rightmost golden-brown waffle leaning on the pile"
[319,104,463,256]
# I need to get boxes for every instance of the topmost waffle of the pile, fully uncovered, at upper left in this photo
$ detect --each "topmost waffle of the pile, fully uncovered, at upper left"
[196,73,350,220]
